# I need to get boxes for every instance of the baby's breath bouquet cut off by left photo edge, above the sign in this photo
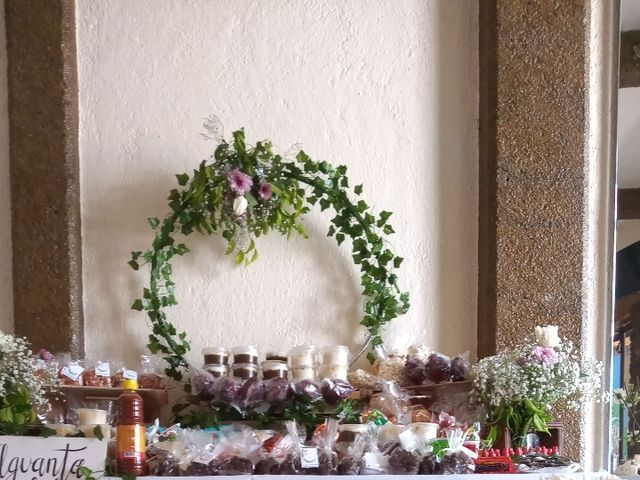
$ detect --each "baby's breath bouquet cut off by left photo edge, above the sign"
[0,332,49,435]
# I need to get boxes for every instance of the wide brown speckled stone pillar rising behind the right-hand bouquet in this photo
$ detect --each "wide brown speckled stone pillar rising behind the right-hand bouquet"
[478,0,615,460]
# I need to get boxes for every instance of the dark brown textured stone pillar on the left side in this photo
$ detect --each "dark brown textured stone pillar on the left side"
[5,0,84,355]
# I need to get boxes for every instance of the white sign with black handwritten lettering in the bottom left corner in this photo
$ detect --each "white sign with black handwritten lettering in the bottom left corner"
[0,436,107,480]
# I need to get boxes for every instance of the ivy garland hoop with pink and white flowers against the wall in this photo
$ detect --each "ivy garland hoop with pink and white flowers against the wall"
[129,130,409,380]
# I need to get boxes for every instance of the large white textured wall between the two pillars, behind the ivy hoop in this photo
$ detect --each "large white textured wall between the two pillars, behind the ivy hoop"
[77,0,478,368]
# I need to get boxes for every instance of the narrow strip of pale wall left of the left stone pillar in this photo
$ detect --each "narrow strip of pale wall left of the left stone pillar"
[0,0,13,332]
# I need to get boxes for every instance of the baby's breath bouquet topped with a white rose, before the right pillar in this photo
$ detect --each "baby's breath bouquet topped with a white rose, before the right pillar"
[473,326,602,445]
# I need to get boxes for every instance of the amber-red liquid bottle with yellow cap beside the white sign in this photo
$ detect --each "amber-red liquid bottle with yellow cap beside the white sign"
[116,379,147,477]
